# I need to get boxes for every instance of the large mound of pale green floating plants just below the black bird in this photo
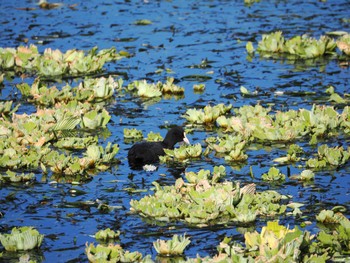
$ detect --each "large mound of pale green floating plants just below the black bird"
[130,168,286,226]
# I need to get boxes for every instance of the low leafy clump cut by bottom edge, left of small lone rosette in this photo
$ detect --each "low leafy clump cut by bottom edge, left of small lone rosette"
[85,243,142,263]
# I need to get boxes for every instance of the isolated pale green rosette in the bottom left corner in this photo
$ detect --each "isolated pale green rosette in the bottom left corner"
[0,226,44,251]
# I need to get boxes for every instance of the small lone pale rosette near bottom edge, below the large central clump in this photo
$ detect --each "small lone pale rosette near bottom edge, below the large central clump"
[153,234,191,256]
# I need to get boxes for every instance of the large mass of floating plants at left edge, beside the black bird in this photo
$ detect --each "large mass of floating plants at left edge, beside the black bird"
[0,78,119,182]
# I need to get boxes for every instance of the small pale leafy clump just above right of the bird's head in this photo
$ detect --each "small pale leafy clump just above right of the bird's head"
[183,103,232,125]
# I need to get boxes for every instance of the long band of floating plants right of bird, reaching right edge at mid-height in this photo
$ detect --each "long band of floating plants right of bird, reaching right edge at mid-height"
[216,105,349,145]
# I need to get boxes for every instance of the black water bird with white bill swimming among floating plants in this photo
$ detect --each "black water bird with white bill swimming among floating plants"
[128,126,190,168]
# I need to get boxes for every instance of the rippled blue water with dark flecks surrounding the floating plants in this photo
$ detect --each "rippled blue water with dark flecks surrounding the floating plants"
[0,0,350,262]
